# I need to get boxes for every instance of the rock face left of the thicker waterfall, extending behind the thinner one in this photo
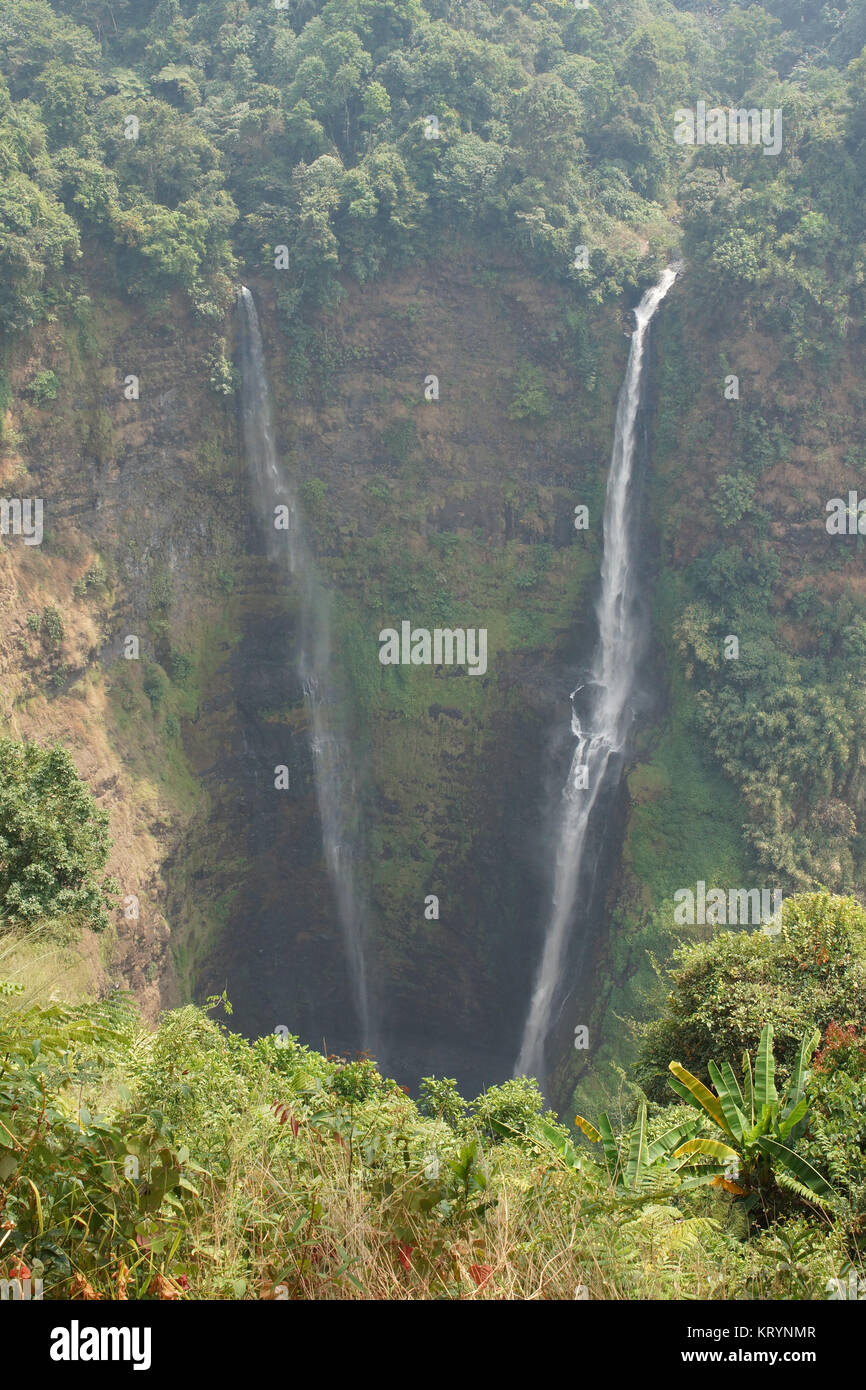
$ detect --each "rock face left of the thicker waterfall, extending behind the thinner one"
[0,244,627,1090]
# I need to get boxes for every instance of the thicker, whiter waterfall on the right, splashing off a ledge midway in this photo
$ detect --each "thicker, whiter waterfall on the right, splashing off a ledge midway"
[514,267,677,1081]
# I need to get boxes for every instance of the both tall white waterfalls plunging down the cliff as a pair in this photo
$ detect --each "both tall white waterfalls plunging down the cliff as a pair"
[239,268,677,1083]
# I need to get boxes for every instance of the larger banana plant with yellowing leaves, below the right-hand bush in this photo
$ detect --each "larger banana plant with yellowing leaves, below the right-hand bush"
[670,1023,837,1208]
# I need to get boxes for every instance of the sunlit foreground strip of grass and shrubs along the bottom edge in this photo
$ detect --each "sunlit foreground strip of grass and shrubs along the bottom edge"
[0,981,845,1300]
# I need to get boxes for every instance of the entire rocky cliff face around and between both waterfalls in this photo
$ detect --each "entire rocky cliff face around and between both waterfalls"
[10,239,863,1098]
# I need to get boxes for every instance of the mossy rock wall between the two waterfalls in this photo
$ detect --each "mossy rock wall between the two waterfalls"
[209,252,627,1090]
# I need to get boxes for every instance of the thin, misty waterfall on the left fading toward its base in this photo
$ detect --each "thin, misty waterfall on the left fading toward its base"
[239,285,371,1048]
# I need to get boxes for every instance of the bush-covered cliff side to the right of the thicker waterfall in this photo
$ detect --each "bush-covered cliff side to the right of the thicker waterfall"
[567,290,866,1111]
